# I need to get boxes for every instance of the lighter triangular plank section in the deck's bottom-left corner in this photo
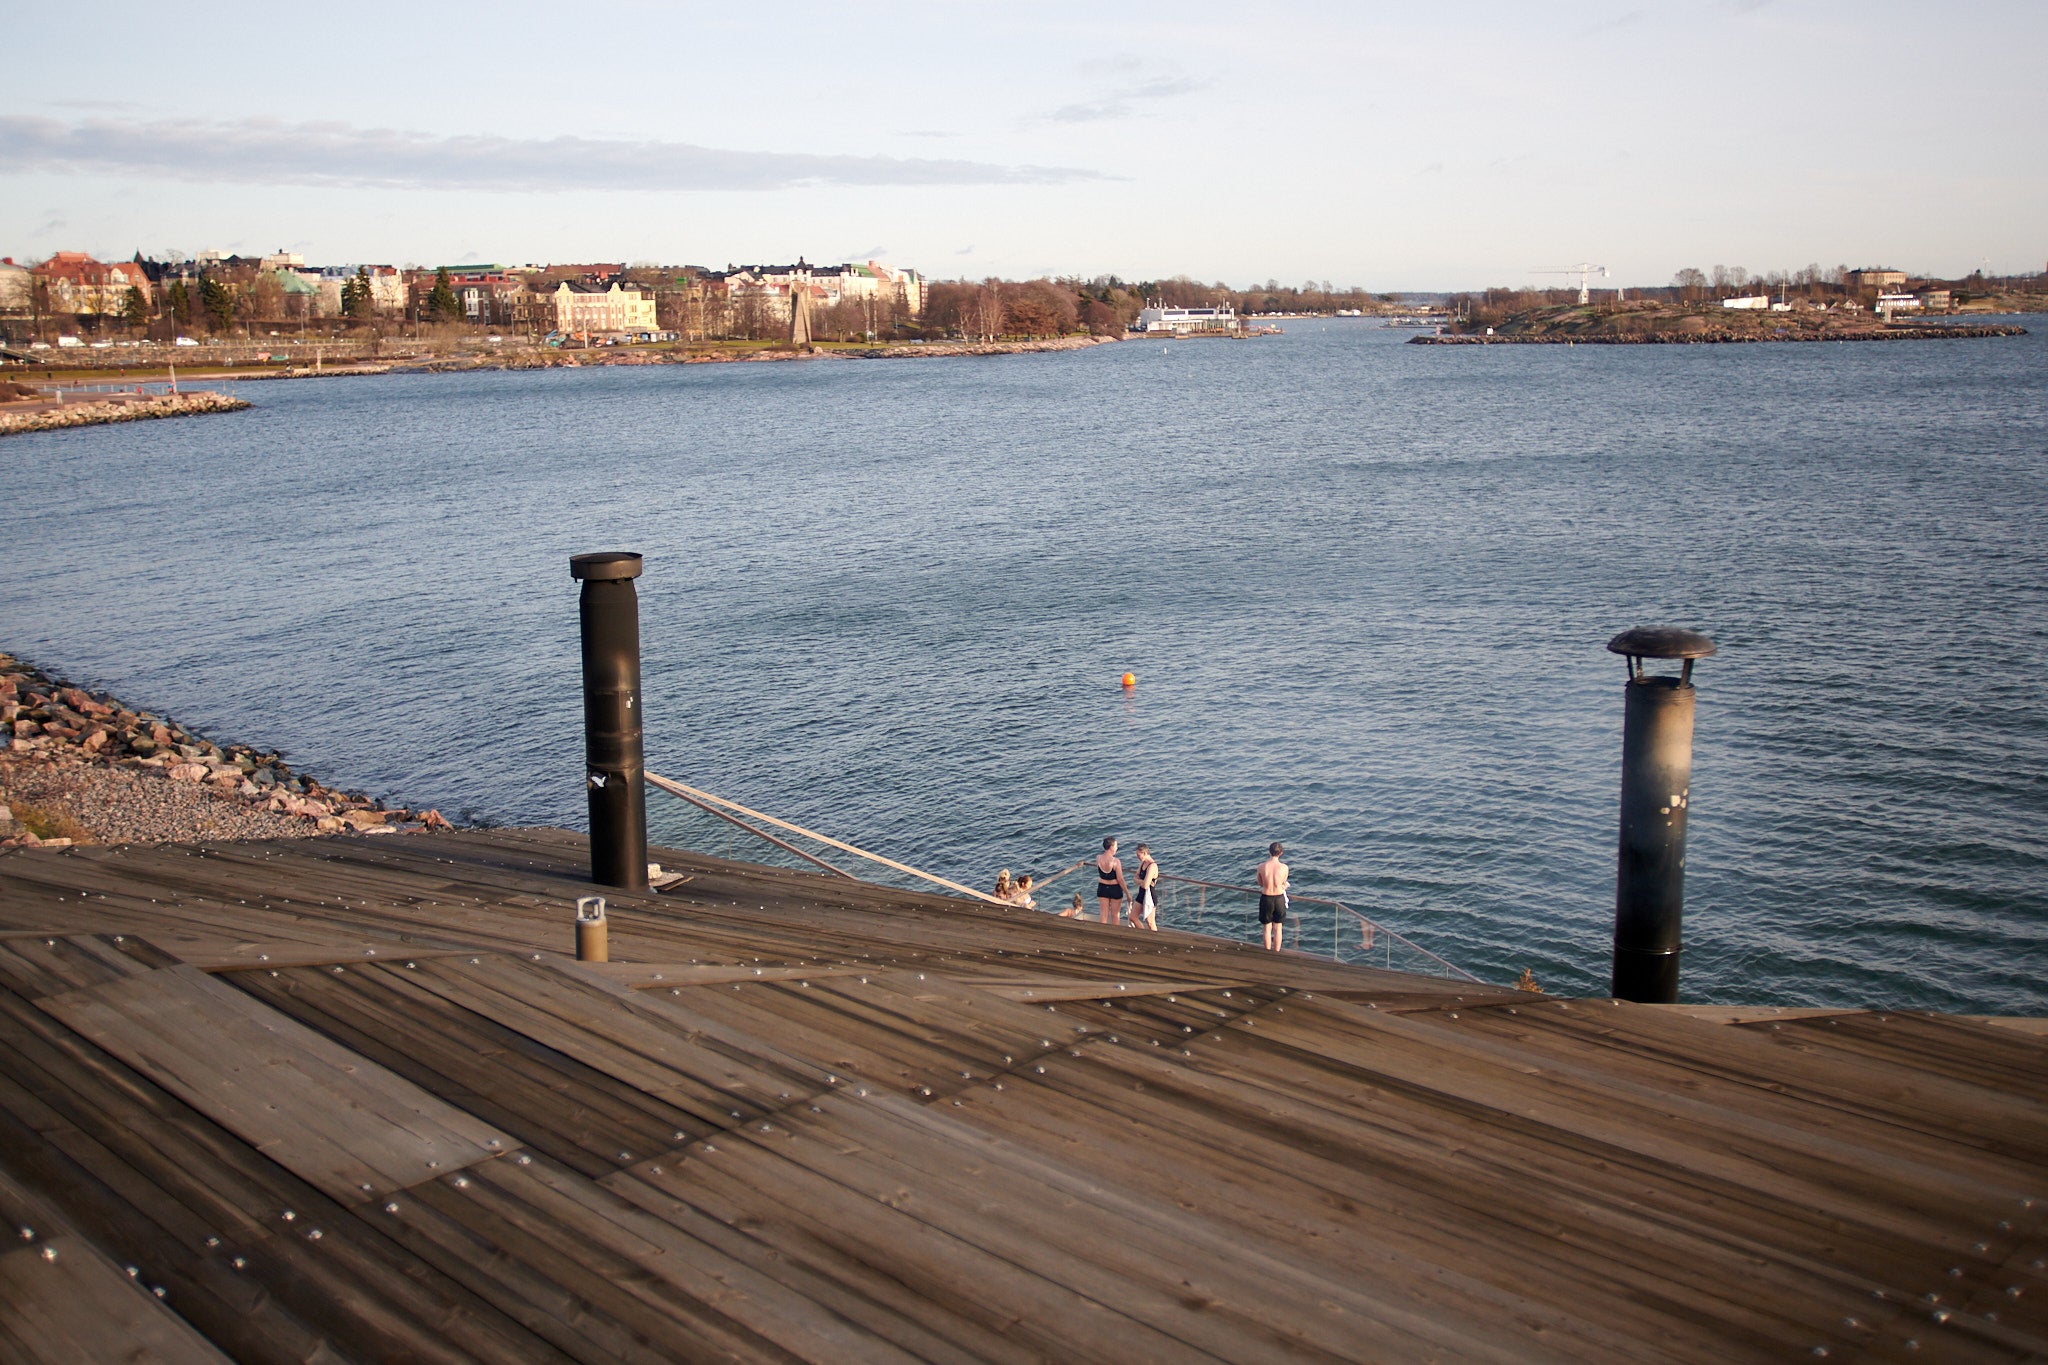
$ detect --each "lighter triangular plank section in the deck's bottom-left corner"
[0,1171,227,1365]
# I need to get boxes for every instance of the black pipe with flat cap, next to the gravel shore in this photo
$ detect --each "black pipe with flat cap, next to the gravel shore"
[569,551,647,890]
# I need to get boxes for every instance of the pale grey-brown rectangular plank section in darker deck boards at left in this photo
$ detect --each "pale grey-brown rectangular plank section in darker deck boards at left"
[37,966,510,1203]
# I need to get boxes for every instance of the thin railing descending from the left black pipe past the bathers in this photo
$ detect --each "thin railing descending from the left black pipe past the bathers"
[647,774,1479,982]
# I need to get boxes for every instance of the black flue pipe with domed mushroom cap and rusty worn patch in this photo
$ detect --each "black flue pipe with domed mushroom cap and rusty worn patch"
[1608,626,1714,1005]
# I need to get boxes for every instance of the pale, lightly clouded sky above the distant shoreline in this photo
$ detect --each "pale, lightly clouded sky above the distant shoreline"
[0,0,2048,291]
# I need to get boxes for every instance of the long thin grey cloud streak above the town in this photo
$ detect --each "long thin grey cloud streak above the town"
[0,115,1106,192]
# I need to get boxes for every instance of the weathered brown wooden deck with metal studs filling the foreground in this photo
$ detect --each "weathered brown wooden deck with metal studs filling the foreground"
[0,831,2048,1363]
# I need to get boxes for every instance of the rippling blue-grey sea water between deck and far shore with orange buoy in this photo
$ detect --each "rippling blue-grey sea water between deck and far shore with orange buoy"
[0,319,2048,1013]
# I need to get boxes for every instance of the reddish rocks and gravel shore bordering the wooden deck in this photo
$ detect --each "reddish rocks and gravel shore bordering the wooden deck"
[0,655,449,849]
